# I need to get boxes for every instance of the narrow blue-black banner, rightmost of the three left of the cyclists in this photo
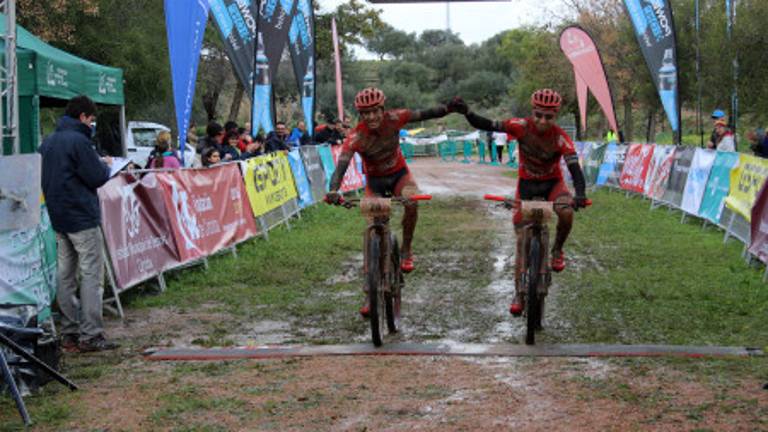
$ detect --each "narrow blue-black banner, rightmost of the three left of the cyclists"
[288,0,315,134]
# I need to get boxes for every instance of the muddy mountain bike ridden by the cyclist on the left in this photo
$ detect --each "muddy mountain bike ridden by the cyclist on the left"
[341,195,432,347]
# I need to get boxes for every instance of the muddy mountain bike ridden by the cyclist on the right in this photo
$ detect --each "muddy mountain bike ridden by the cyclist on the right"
[483,195,592,345]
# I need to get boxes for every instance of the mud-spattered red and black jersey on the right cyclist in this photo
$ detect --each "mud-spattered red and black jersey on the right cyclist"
[500,118,576,180]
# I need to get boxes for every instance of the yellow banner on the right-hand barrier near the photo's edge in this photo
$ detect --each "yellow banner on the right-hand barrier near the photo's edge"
[725,154,768,221]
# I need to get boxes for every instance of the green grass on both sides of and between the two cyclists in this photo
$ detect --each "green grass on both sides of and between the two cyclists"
[0,190,768,431]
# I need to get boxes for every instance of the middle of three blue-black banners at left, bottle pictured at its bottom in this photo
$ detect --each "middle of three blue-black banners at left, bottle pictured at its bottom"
[251,0,296,133]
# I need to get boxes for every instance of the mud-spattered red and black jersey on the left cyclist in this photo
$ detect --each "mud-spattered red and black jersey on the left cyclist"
[341,109,413,177]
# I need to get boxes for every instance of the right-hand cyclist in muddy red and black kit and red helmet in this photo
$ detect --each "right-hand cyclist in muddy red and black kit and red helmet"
[449,89,588,315]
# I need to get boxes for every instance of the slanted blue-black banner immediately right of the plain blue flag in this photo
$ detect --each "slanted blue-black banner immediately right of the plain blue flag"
[208,0,259,95]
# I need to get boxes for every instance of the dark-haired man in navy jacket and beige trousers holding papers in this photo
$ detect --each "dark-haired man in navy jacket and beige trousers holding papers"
[39,96,117,352]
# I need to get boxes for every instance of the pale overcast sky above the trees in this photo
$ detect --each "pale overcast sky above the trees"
[316,0,565,54]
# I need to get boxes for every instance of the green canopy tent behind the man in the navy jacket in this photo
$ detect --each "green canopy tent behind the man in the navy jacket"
[0,14,125,154]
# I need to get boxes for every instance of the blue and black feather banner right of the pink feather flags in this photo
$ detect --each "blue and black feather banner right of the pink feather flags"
[624,0,680,138]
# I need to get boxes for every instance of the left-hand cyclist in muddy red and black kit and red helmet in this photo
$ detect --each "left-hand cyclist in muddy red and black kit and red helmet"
[325,87,460,316]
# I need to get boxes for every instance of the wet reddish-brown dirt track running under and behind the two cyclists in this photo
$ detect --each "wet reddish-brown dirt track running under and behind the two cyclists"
[9,159,768,431]
